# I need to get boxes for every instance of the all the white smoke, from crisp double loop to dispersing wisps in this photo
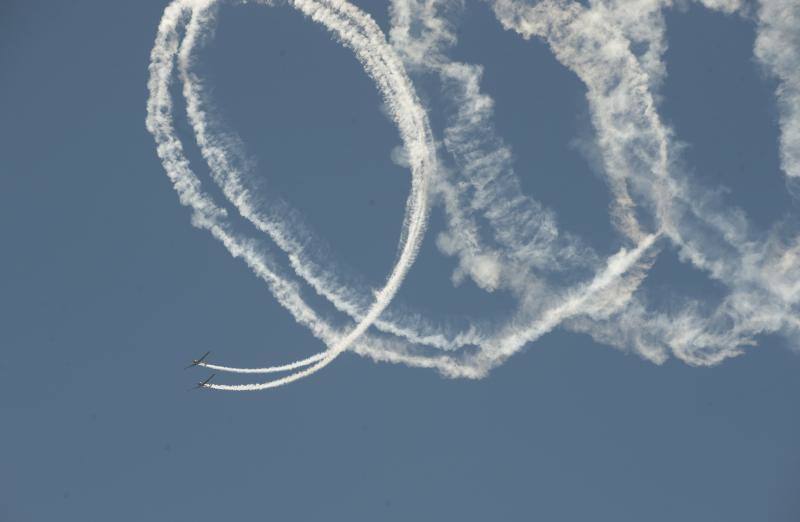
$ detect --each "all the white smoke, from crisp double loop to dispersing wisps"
[147,0,800,391]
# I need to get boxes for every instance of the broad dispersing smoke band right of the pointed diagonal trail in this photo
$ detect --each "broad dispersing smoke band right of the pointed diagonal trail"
[493,0,798,364]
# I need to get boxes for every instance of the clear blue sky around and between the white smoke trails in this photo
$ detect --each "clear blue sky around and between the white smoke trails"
[0,0,800,522]
